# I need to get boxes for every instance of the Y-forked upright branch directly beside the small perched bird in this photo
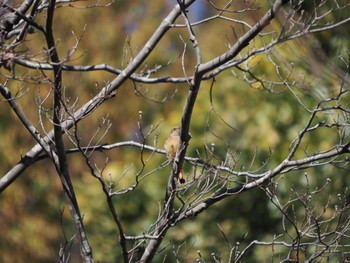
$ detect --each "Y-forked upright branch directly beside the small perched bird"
[141,0,288,262]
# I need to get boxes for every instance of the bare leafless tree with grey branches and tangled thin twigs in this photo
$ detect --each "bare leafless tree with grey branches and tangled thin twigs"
[0,0,350,262]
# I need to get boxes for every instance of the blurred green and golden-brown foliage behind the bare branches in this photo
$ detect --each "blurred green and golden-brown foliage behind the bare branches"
[0,0,350,262]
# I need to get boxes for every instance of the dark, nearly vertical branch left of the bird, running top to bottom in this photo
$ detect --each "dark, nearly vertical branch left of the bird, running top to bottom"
[45,0,93,262]
